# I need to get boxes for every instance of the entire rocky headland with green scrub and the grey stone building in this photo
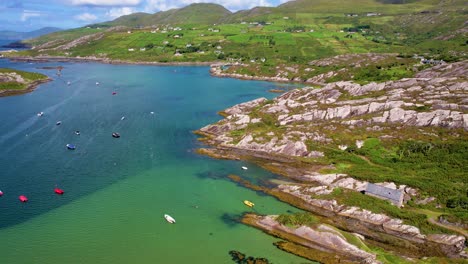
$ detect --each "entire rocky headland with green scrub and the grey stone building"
[197,58,468,263]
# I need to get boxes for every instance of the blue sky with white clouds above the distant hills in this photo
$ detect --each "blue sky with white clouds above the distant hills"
[0,0,289,32]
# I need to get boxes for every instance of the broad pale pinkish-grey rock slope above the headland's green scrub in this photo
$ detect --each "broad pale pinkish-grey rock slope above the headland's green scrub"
[202,61,468,164]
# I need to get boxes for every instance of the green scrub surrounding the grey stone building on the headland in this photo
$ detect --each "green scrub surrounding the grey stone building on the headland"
[318,138,468,228]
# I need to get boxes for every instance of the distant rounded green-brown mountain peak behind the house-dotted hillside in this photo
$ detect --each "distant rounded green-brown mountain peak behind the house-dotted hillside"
[90,3,232,27]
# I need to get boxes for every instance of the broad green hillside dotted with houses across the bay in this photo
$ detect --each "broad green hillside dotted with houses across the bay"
[8,0,468,67]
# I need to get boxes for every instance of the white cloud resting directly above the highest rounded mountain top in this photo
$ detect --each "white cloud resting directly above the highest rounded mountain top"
[145,0,274,13]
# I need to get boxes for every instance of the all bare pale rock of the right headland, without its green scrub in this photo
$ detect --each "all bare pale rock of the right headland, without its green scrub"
[197,61,468,263]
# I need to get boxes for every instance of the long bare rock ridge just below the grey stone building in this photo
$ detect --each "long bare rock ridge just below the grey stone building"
[278,184,465,257]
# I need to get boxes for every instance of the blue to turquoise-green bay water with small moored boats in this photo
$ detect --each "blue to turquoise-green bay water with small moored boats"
[0,60,309,264]
